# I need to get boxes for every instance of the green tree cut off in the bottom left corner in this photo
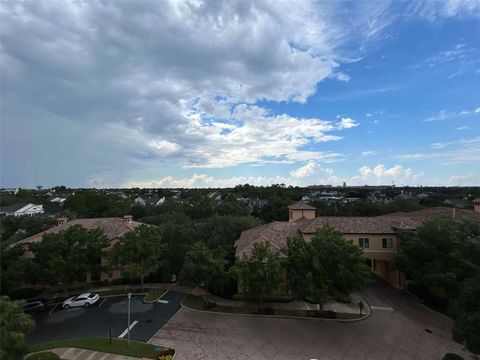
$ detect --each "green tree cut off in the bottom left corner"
[0,296,35,360]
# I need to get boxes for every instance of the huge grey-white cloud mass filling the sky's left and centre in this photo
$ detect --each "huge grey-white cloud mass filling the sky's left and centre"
[0,0,391,184]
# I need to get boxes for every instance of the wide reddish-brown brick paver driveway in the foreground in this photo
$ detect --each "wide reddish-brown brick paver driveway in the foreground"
[150,284,471,360]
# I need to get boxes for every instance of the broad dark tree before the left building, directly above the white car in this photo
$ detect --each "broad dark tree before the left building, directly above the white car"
[28,225,107,292]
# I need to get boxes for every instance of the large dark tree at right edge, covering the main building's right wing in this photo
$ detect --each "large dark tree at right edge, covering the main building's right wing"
[395,217,480,298]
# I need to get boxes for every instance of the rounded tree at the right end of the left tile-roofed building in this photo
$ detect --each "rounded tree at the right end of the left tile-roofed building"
[109,225,166,289]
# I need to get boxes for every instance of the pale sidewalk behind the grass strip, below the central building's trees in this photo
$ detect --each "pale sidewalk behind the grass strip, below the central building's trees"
[197,288,370,315]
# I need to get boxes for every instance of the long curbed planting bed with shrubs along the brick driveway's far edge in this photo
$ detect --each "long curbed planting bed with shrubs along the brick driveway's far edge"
[182,294,365,320]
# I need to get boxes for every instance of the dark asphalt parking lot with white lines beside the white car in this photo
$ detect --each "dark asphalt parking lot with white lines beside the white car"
[27,291,185,344]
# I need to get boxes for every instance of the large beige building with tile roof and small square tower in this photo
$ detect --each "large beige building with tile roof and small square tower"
[235,199,480,288]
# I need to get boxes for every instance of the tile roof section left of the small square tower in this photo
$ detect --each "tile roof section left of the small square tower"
[235,221,300,256]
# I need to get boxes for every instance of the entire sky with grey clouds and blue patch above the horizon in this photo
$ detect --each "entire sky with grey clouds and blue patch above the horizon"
[0,0,480,188]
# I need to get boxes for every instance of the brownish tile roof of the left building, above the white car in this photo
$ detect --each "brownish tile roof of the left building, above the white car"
[14,218,143,245]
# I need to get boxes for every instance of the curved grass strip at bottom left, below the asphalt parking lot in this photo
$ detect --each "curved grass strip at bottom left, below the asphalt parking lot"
[29,337,163,359]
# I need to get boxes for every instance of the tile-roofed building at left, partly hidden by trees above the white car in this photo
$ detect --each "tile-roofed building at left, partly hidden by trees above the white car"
[14,215,143,281]
